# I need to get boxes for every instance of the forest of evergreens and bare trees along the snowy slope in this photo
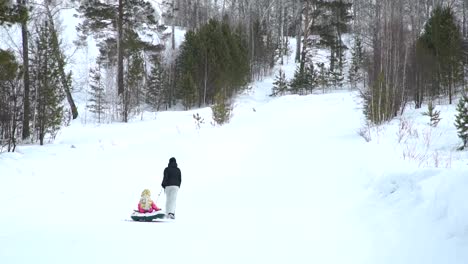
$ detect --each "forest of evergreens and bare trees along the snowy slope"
[0,0,468,152]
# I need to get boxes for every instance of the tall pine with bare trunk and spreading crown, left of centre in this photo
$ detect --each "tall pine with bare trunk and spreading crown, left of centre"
[78,0,166,122]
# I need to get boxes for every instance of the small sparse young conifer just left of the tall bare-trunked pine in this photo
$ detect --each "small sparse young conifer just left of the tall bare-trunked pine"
[87,65,107,123]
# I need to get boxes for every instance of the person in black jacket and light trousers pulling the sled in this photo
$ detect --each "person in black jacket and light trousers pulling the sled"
[161,157,182,219]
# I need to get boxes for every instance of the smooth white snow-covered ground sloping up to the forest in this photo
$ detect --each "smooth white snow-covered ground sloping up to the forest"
[0,3,468,264]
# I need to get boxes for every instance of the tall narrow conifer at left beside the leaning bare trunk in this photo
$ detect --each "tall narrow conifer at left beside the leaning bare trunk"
[31,20,65,145]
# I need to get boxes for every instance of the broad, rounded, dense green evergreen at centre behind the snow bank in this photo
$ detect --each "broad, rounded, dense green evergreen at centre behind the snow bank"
[176,20,249,108]
